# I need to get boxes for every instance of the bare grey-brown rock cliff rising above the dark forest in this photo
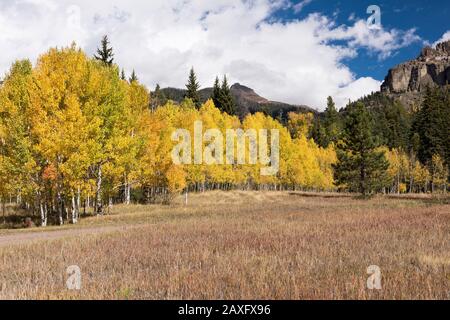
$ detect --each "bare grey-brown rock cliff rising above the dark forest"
[381,41,450,94]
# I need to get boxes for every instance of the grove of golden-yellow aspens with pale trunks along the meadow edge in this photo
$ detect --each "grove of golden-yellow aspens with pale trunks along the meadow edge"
[0,44,336,226]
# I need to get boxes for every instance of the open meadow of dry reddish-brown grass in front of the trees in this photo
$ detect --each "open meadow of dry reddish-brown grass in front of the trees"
[0,192,450,299]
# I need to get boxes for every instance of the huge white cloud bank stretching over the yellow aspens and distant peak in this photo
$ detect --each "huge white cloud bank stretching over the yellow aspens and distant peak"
[0,0,418,109]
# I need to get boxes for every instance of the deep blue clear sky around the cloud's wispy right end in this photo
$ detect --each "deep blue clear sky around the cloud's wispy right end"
[282,0,450,80]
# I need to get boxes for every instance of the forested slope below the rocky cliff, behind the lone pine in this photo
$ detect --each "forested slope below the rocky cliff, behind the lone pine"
[310,86,450,193]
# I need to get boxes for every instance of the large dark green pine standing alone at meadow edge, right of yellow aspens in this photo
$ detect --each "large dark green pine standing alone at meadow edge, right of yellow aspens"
[334,103,389,196]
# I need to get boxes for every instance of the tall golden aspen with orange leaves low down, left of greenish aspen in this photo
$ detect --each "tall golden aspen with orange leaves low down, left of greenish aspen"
[29,45,93,224]
